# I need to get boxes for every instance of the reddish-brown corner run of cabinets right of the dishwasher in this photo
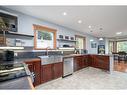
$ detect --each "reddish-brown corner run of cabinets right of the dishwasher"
[74,55,110,71]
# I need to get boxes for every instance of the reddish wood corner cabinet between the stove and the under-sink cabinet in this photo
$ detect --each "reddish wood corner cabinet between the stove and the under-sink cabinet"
[25,59,41,86]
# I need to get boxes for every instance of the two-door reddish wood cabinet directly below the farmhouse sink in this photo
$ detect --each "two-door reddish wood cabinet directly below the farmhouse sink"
[41,62,63,83]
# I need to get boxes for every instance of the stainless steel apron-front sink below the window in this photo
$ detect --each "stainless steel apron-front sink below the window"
[39,55,63,65]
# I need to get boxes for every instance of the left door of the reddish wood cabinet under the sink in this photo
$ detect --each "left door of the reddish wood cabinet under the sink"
[41,64,53,83]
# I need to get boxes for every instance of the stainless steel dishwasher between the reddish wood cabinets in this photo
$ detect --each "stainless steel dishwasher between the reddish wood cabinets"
[63,57,74,78]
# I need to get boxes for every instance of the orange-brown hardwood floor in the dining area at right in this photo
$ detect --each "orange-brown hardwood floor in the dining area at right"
[114,61,127,73]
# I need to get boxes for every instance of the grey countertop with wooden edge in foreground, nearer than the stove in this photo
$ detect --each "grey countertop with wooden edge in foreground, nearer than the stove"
[0,76,34,90]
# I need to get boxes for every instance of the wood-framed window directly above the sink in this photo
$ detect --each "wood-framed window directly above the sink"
[33,25,57,50]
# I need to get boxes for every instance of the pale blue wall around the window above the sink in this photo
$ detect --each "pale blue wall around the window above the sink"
[0,7,98,54]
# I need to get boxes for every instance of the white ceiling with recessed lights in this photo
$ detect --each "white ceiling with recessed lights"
[3,6,127,37]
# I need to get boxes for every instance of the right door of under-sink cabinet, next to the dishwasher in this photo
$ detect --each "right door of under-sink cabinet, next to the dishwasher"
[53,63,63,79]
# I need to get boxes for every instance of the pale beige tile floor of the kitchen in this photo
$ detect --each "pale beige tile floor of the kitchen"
[36,67,127,90]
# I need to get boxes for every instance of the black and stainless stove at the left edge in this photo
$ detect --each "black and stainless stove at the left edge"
[0,63,30,82]
